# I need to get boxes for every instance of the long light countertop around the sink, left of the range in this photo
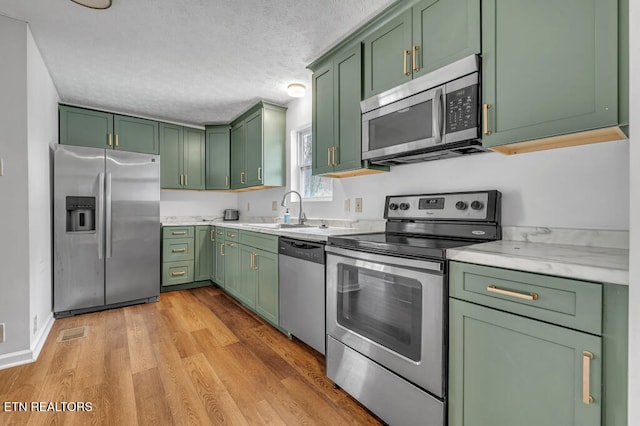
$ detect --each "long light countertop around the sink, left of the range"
[161,217,384,242]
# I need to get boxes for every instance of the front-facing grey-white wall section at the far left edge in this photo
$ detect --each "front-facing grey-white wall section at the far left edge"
[0,15,31,365]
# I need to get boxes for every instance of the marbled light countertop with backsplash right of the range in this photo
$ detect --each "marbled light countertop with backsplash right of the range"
[447,227,629,285]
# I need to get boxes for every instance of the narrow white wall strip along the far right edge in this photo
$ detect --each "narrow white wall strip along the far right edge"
[628,1,640,425]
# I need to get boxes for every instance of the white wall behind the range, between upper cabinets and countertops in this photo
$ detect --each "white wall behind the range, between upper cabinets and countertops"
[238,95,629,230]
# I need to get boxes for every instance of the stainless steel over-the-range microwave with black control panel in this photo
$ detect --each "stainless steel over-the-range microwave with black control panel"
[360,55,486,165]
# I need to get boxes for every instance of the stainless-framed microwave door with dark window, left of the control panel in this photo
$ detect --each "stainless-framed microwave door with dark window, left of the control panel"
[362,87,443,160]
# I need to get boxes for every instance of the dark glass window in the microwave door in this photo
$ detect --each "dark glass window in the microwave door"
[369,100,433,151]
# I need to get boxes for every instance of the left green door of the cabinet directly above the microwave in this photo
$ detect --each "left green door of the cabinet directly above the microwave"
[363,10,412,98]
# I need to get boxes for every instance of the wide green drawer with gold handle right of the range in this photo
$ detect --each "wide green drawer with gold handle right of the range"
[449,262,602,335]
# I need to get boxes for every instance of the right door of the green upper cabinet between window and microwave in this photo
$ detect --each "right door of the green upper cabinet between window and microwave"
[332,46,362,172]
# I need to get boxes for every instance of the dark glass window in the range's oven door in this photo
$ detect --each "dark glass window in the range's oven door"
[337,264,422,361]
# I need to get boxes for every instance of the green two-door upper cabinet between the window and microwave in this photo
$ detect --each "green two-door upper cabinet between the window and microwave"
[312,44,388,177]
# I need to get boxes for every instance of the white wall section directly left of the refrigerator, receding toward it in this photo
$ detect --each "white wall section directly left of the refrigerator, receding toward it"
[27,27,60,356]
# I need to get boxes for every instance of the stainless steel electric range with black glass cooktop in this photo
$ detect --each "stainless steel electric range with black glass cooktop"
[326,190,501,426]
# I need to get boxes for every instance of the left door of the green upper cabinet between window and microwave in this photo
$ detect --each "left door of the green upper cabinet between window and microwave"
[311,62,336,175]
